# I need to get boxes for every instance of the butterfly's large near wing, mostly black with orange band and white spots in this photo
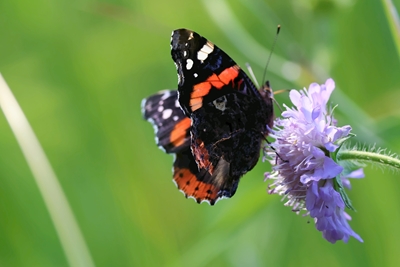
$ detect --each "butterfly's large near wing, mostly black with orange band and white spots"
[171,29,273,197]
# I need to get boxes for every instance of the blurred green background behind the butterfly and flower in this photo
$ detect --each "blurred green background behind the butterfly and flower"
[0,0,400,266]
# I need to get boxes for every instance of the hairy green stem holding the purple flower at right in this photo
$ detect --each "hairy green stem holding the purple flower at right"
[337,149,400,170]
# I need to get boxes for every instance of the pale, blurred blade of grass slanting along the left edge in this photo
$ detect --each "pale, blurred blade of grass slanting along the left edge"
[0,74,94,267]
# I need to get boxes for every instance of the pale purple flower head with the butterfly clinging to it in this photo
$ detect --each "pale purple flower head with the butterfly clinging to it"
[265,79,364,243]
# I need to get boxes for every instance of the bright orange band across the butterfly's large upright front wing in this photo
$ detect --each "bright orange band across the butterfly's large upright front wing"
[190,65,240,112]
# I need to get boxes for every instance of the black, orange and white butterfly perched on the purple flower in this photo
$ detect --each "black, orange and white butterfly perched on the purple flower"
[142,29,273,205]
